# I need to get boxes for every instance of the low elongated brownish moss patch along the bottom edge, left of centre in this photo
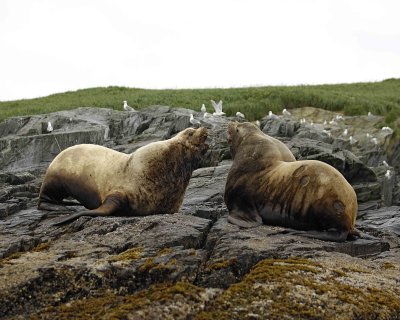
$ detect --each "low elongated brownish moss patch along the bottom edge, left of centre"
[31,282,204,319]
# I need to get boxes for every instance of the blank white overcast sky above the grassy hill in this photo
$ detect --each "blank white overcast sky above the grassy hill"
[0,0,400,101]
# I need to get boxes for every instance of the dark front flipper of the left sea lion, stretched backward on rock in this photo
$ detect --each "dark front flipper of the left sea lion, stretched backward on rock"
[53,194,125,226]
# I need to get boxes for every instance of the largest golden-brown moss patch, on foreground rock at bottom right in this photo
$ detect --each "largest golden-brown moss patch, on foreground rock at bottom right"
[196,258,400,319]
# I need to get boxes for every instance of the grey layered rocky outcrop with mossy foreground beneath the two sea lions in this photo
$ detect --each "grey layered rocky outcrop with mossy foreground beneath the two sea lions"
[0,106,400,319]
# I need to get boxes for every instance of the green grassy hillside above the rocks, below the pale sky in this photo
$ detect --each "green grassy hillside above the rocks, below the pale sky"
[0,79,400,124]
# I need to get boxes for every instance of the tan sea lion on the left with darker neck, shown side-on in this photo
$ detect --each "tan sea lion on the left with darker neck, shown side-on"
[38,128,208,224]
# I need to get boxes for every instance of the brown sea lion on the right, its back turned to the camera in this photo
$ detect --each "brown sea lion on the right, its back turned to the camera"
[224,122,358,241]
